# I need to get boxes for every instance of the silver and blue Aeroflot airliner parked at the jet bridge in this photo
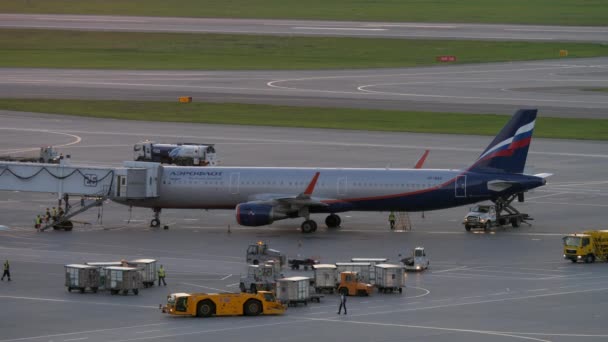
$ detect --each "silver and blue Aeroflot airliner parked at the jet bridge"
[125,109,550,233]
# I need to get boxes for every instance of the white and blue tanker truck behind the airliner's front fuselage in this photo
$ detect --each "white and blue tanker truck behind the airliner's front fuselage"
[133,140,218,166]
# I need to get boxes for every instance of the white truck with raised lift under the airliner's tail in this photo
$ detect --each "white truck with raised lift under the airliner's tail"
[462,195,532,231]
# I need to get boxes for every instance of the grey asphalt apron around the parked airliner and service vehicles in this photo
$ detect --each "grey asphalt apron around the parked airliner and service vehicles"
[0,108,608,341]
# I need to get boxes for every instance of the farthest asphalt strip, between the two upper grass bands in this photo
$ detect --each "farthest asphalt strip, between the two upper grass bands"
[0,14,608,43]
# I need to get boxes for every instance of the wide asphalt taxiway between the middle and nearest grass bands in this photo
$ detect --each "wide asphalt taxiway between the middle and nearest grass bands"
[0,58,608,118]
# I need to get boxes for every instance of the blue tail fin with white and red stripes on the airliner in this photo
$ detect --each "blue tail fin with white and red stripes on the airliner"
[469,109,538,173]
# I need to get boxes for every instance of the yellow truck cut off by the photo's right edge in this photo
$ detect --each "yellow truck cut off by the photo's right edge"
[563,230,608,263]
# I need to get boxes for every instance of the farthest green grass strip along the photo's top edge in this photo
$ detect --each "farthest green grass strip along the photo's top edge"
[0,0,608,26]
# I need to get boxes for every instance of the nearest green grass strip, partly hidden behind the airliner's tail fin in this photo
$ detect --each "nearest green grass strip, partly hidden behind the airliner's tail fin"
[0,99,608,140]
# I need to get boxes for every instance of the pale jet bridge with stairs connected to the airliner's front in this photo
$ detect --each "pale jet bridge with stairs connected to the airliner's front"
[0,159,162,230]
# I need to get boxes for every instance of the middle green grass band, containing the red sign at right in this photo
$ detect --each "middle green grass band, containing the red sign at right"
[0,29,608,70]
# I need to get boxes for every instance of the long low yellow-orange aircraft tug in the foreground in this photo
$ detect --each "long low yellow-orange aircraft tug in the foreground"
[161,291,285,317]
